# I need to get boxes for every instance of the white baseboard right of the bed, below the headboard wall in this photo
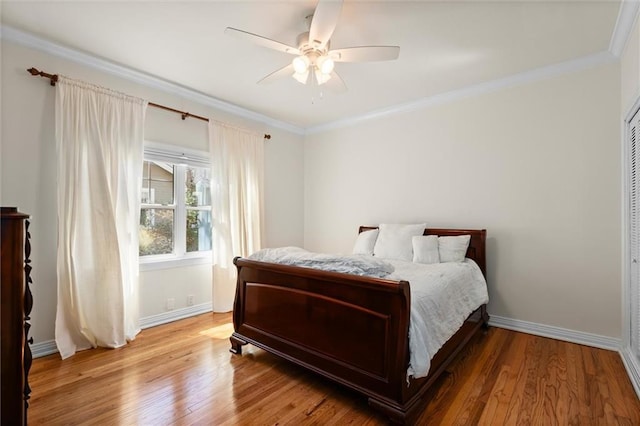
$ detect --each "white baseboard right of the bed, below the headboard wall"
[489,315,621,352]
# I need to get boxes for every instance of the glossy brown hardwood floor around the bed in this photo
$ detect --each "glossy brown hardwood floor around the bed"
[28,314,640,426]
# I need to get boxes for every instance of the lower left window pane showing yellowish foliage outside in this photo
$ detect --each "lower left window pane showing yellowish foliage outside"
[139,209,173,256]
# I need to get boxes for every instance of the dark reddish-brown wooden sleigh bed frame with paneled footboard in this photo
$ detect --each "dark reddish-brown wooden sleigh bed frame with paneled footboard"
[230,227,489,423]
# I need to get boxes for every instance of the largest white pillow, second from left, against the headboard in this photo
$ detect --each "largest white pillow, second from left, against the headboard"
[373,223,427,262]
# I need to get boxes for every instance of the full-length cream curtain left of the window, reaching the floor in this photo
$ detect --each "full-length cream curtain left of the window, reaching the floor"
[55,76,147,359]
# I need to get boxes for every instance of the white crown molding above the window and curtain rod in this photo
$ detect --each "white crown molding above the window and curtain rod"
[0,25,304,135]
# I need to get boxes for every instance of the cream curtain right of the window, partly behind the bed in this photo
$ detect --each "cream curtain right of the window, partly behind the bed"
[209,121,264,312]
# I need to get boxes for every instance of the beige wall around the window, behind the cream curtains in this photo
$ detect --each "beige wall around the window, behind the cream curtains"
[0,40,304,343]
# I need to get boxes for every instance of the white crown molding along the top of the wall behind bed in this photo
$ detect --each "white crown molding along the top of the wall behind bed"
[306,52,618,134]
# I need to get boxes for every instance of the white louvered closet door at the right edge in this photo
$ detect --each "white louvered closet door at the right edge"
[628,106,640,362]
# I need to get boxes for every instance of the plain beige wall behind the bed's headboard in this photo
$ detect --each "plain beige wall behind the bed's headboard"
[304,64,621,338]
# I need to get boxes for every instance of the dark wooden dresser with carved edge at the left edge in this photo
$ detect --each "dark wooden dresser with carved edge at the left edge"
[0,207,33,425]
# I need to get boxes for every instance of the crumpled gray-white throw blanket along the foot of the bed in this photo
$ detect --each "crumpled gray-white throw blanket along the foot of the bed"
[247,247,395,278]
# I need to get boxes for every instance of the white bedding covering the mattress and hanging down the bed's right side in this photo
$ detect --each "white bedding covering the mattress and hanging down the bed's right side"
[249,247,489,380]
